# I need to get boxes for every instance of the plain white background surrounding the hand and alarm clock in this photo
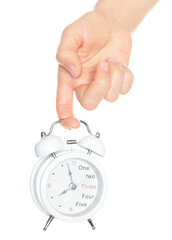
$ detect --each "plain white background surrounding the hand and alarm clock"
[0,0,172,240]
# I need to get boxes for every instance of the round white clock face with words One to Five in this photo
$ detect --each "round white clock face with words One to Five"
[46,158,102,217]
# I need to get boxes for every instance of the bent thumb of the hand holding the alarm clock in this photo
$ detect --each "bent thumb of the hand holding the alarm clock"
[56,25,82,78]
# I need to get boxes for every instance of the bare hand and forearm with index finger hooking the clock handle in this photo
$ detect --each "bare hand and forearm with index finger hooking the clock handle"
[56,0,157,129]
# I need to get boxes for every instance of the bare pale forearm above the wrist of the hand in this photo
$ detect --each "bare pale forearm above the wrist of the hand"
[95,0,159,32]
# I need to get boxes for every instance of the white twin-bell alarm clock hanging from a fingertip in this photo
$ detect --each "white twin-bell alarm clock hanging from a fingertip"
[30,119,107,230]
